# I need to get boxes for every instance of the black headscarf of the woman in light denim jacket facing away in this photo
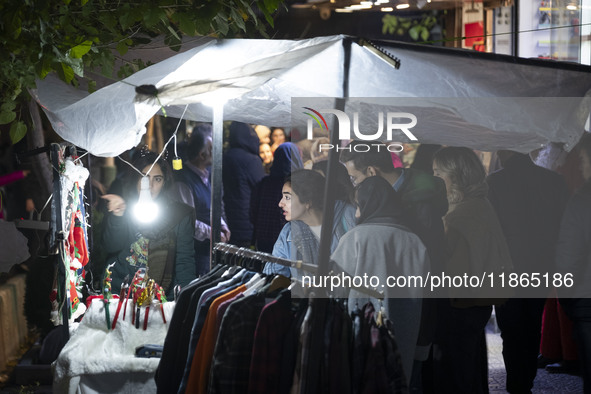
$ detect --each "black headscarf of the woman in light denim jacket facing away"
[356,176,404,224]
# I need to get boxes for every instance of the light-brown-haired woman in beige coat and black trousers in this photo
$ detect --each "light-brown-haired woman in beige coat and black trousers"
[433,147,512,394]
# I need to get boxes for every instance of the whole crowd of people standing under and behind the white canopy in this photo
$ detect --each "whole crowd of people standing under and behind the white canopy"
[16,122,591,393]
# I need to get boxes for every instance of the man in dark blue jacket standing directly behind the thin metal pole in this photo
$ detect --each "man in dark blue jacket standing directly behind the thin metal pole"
[171,123,230,275]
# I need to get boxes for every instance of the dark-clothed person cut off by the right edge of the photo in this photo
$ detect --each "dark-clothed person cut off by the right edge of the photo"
[556,133,591,393]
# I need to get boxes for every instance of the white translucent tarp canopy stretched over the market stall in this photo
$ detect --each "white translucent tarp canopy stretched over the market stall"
[36,36,591,156]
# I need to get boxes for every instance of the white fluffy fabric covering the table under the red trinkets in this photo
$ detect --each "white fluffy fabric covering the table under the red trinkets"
[52,299,175,393]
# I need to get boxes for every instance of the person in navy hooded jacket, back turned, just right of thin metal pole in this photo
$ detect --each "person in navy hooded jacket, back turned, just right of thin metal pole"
[222,122,265,247]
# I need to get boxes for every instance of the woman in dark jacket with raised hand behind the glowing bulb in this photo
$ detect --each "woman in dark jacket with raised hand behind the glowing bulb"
[102,152,196,299]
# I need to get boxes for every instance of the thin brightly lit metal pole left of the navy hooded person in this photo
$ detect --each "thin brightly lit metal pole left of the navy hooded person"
[209,102,224,269]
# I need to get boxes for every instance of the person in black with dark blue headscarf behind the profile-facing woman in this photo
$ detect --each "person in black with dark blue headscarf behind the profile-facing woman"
[250,142,303,253]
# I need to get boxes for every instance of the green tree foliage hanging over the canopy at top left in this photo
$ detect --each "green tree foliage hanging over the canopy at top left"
[0,0,282,142]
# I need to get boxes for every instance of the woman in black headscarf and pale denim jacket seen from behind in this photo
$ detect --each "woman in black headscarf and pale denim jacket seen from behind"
[331,176,429,384]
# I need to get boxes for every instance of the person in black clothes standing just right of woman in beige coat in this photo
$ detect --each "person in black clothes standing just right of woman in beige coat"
[487,151,568,393]
